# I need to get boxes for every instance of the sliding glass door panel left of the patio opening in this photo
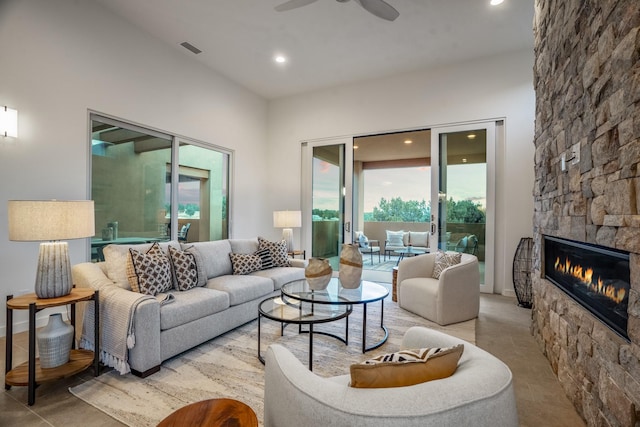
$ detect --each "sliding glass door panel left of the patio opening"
[302,139,353,271]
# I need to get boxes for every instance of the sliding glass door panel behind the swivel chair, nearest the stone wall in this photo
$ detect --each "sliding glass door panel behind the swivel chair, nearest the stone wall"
[431,122,496,293]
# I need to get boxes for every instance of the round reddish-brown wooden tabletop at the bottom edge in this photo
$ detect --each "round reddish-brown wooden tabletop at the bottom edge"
[158,399,258,427]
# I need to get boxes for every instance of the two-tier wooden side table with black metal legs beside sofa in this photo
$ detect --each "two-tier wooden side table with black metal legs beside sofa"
[4,288,100,406]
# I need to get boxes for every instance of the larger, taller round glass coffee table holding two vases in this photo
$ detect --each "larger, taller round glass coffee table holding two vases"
[280,278,389,353]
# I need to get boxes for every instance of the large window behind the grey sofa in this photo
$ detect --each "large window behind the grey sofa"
[91,114,230,260]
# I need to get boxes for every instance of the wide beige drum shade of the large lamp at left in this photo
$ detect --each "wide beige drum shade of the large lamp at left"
[8,200,95,241]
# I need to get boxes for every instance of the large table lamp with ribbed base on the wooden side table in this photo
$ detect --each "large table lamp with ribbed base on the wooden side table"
[8,200,95,298]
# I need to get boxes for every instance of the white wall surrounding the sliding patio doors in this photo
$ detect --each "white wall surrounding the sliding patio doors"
[268,51,535,294]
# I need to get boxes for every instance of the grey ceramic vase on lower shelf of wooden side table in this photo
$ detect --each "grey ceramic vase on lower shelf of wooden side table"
[38,313,73,369]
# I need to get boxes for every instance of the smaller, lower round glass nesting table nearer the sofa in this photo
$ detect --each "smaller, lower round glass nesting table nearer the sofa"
[258,296,352,371]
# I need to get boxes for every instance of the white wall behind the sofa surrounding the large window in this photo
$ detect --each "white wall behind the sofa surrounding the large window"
[0,0,270,335]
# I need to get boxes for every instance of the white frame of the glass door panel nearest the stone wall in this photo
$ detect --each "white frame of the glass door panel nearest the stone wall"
[430,120,497,293]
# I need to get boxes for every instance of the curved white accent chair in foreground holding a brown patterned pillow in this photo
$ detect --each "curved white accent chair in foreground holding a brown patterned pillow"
[264,326,518,427]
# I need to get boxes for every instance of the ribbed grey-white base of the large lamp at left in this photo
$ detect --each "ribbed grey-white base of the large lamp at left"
[35,242,72,298]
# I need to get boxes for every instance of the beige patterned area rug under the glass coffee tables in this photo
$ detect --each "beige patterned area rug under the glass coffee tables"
[70,288,476,427]
